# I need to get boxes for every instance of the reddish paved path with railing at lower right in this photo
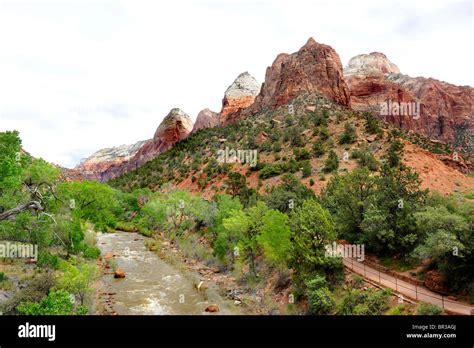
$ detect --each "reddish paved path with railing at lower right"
[343,258,474,315]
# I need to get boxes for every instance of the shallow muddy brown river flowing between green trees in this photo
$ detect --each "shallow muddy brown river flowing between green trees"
[97,231,241,315]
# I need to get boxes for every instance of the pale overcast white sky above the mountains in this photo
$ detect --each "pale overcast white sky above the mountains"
[0,0,474,168]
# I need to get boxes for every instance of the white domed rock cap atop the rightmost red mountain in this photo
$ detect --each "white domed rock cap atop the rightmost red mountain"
[344,52,400,76]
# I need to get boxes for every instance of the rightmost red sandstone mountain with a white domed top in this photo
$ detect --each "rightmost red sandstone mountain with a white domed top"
[344,52,474,151]
